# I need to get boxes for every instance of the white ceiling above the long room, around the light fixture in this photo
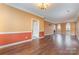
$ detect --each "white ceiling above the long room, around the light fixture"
[7,3,79,23]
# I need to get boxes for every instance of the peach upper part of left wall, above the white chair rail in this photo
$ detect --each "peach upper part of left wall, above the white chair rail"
[0,4,44,32]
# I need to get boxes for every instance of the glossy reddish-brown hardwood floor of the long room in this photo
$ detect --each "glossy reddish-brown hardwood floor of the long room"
[0,33,79,55]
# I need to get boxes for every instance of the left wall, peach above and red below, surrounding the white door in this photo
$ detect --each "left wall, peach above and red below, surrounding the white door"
[0,4,44,45]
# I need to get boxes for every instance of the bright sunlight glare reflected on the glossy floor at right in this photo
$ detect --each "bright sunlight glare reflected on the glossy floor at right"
[53,32,78,53]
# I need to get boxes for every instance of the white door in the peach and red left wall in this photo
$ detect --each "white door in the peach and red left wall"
[32,21,39,39]
